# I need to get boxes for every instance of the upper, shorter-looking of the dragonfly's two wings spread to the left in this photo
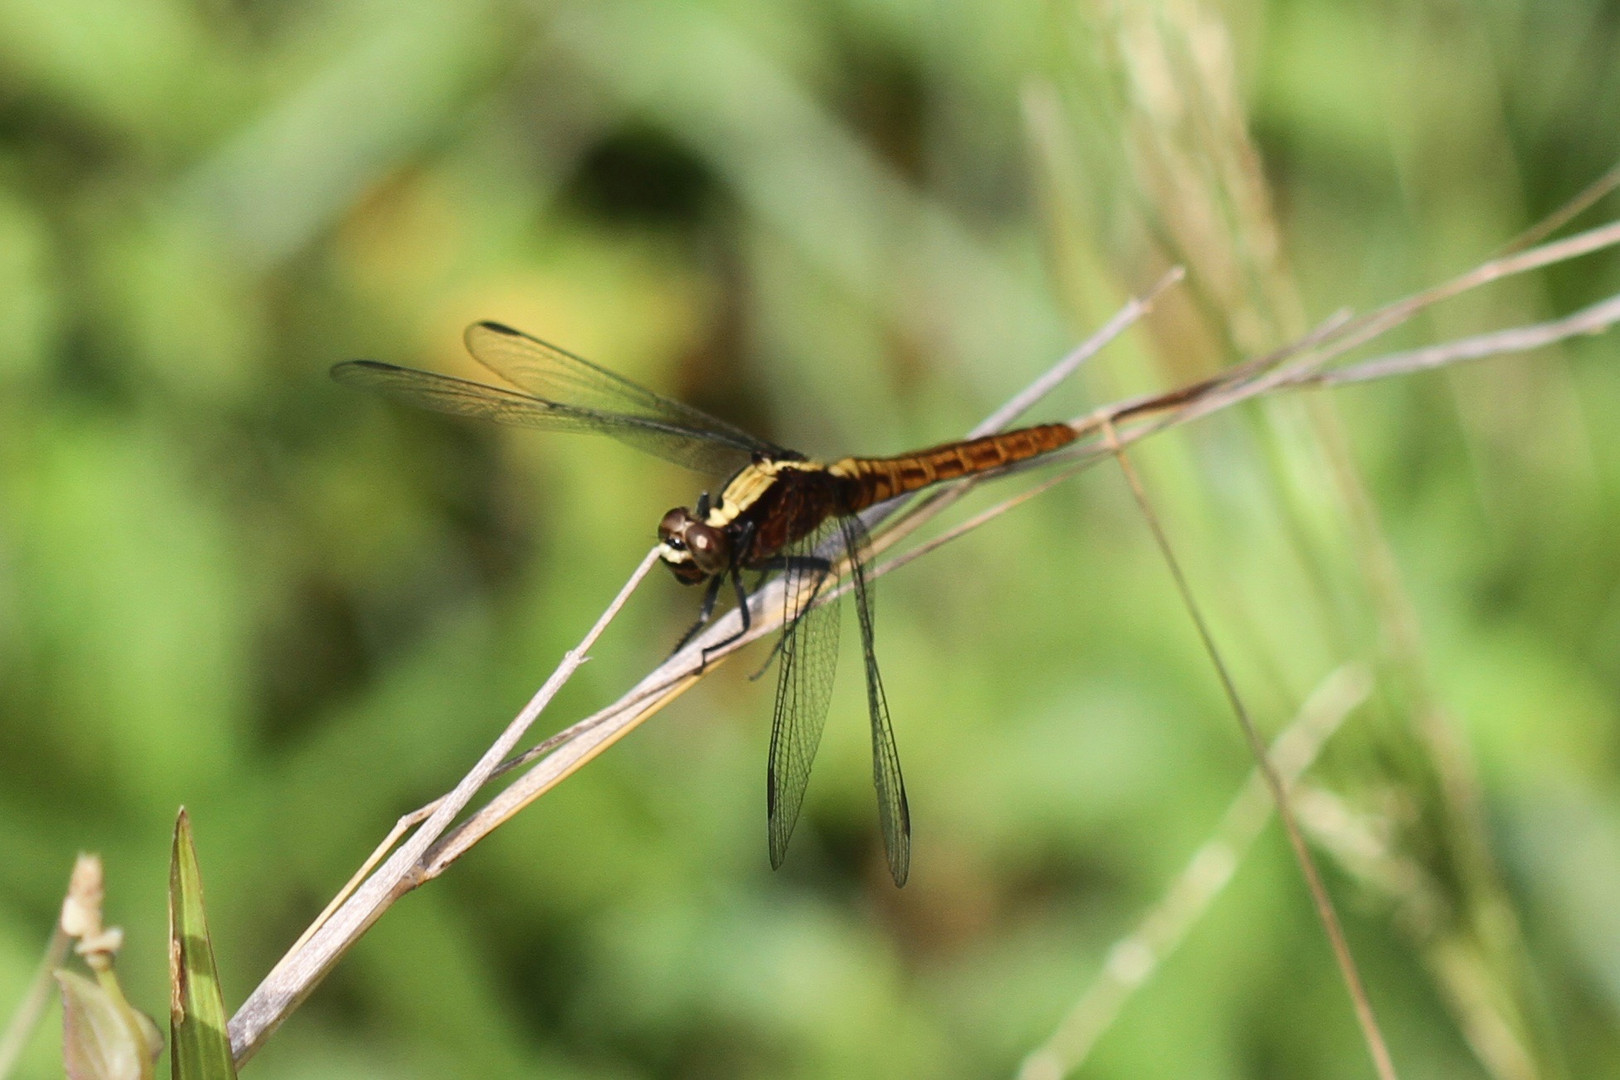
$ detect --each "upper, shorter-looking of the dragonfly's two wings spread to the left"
[463,322,784,472]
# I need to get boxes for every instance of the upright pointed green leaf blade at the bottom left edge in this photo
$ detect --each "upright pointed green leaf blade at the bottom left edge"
[168,808,237,1080]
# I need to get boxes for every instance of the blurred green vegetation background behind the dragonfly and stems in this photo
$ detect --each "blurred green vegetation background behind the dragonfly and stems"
[0,0,1620,1080]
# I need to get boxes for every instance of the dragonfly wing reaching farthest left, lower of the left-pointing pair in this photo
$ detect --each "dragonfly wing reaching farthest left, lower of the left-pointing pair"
[332,359,753,476]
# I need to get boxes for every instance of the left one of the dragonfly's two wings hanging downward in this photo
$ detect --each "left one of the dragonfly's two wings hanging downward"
[765,528,839,870]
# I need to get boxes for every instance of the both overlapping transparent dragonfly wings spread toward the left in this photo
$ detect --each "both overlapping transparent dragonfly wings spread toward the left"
[332,322,784,476]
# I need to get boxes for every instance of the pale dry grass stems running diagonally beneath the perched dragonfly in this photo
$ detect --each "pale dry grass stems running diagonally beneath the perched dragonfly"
[232,210,1620,1075]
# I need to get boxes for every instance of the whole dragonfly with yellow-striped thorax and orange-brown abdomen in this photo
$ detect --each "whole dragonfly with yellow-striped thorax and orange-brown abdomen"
[332,322,1079,886]
